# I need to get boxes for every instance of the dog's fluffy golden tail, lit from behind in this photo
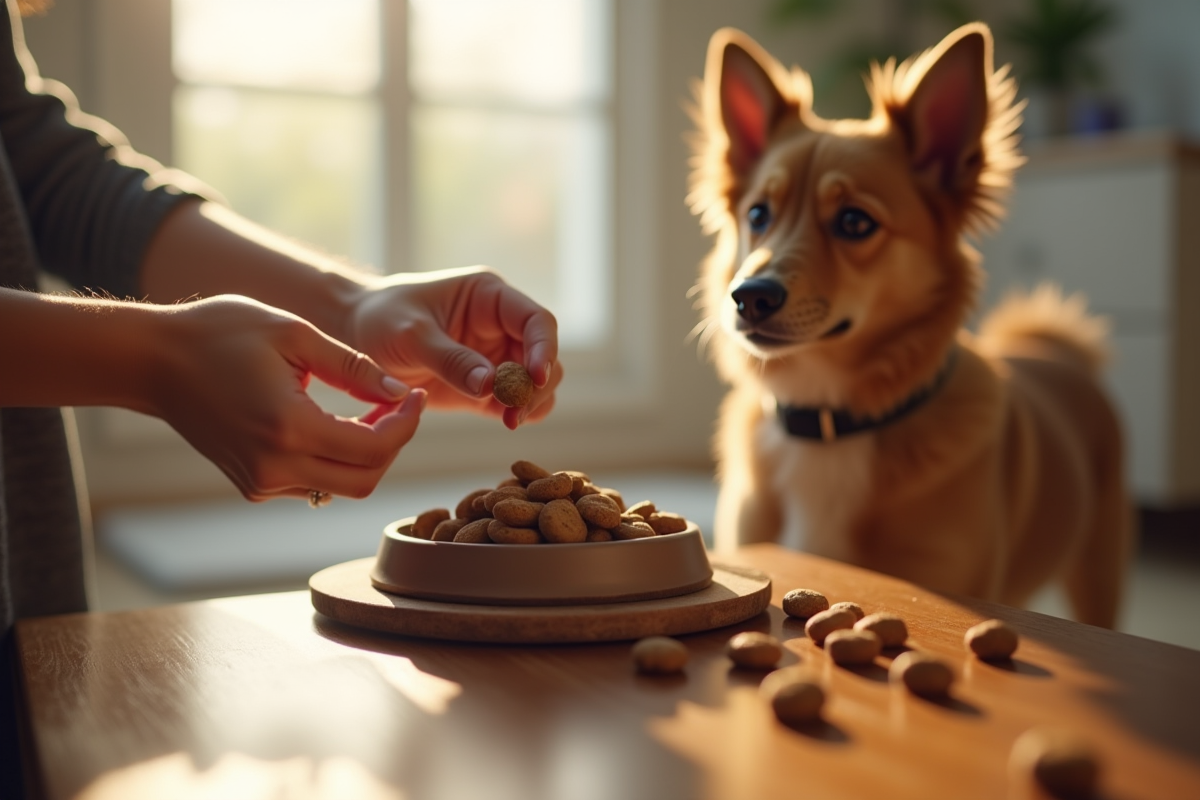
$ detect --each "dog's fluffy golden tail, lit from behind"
[976,283,1109,375]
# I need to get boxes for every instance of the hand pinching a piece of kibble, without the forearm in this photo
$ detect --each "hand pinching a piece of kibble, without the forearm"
[347,267,563,429]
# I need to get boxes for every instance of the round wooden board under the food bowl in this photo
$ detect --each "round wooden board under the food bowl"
[308,558,770,644]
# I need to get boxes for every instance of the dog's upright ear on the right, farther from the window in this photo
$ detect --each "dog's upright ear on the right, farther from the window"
[892,23,991,192]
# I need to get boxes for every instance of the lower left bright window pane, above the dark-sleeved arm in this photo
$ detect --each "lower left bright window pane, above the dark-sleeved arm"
[174,86,383,267]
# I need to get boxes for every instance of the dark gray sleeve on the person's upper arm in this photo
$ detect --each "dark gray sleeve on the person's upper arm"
[0,4,213,297]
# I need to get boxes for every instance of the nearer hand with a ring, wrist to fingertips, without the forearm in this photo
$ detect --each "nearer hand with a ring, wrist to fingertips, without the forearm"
[150,296,425,501]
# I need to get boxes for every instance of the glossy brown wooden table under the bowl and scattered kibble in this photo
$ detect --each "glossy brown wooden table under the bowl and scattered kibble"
[17,546,1200,800]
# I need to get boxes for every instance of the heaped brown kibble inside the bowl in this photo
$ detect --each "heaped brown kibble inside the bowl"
[407,461,688,545]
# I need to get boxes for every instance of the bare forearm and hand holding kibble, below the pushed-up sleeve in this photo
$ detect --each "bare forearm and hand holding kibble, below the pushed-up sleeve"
[142,201,562,427]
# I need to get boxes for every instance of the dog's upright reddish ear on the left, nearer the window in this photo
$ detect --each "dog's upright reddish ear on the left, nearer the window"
[704,28,796,175]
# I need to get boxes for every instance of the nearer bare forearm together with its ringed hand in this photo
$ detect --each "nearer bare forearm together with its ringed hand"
[0,289,425,500]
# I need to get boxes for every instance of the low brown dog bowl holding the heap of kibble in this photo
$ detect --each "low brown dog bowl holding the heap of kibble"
[371,517,713,606]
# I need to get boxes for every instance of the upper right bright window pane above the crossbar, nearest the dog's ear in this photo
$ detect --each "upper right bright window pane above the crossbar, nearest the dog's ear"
[409,0,608,104]
